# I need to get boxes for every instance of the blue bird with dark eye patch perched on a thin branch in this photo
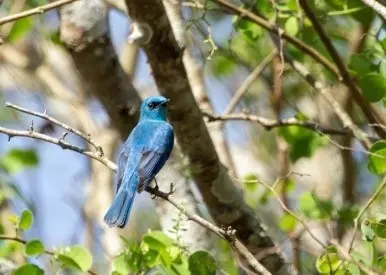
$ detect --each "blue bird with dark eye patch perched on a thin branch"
[104,96,174,228]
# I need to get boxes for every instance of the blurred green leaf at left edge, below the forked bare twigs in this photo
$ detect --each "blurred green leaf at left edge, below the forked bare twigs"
[0,149,39,174]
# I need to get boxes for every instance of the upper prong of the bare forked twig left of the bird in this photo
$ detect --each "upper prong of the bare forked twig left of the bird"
[5,102,103,155]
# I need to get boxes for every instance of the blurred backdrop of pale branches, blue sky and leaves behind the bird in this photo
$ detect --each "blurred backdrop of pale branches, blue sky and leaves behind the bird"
[0,0,386,274]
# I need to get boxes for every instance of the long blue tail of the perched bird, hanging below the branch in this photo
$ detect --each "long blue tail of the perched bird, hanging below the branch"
[104,190,136,228]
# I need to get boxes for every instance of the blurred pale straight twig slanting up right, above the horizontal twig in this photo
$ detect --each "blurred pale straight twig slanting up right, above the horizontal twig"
[224,50,277,115]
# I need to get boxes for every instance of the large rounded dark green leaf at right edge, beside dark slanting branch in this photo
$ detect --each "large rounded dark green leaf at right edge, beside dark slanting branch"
[358,72,386,102]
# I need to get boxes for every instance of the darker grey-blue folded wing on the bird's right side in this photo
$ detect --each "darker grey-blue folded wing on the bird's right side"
[137,123,174,193]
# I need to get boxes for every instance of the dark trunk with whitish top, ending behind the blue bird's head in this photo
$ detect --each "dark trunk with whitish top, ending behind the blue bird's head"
[60,0,141,139]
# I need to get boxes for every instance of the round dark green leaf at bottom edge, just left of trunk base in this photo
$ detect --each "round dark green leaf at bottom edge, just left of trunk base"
[189,251,216,275]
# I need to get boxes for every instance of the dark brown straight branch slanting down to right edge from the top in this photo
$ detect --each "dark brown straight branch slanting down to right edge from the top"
[299,0,386,138]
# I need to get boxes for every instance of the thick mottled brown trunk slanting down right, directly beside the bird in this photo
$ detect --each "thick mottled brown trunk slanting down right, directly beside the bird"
[126,0,290,274]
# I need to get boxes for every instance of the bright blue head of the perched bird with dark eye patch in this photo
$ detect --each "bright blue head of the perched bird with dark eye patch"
[140,96,169,121]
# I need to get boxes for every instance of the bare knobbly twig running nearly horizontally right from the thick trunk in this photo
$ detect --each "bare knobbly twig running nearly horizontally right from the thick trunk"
[203,112,350,136]
